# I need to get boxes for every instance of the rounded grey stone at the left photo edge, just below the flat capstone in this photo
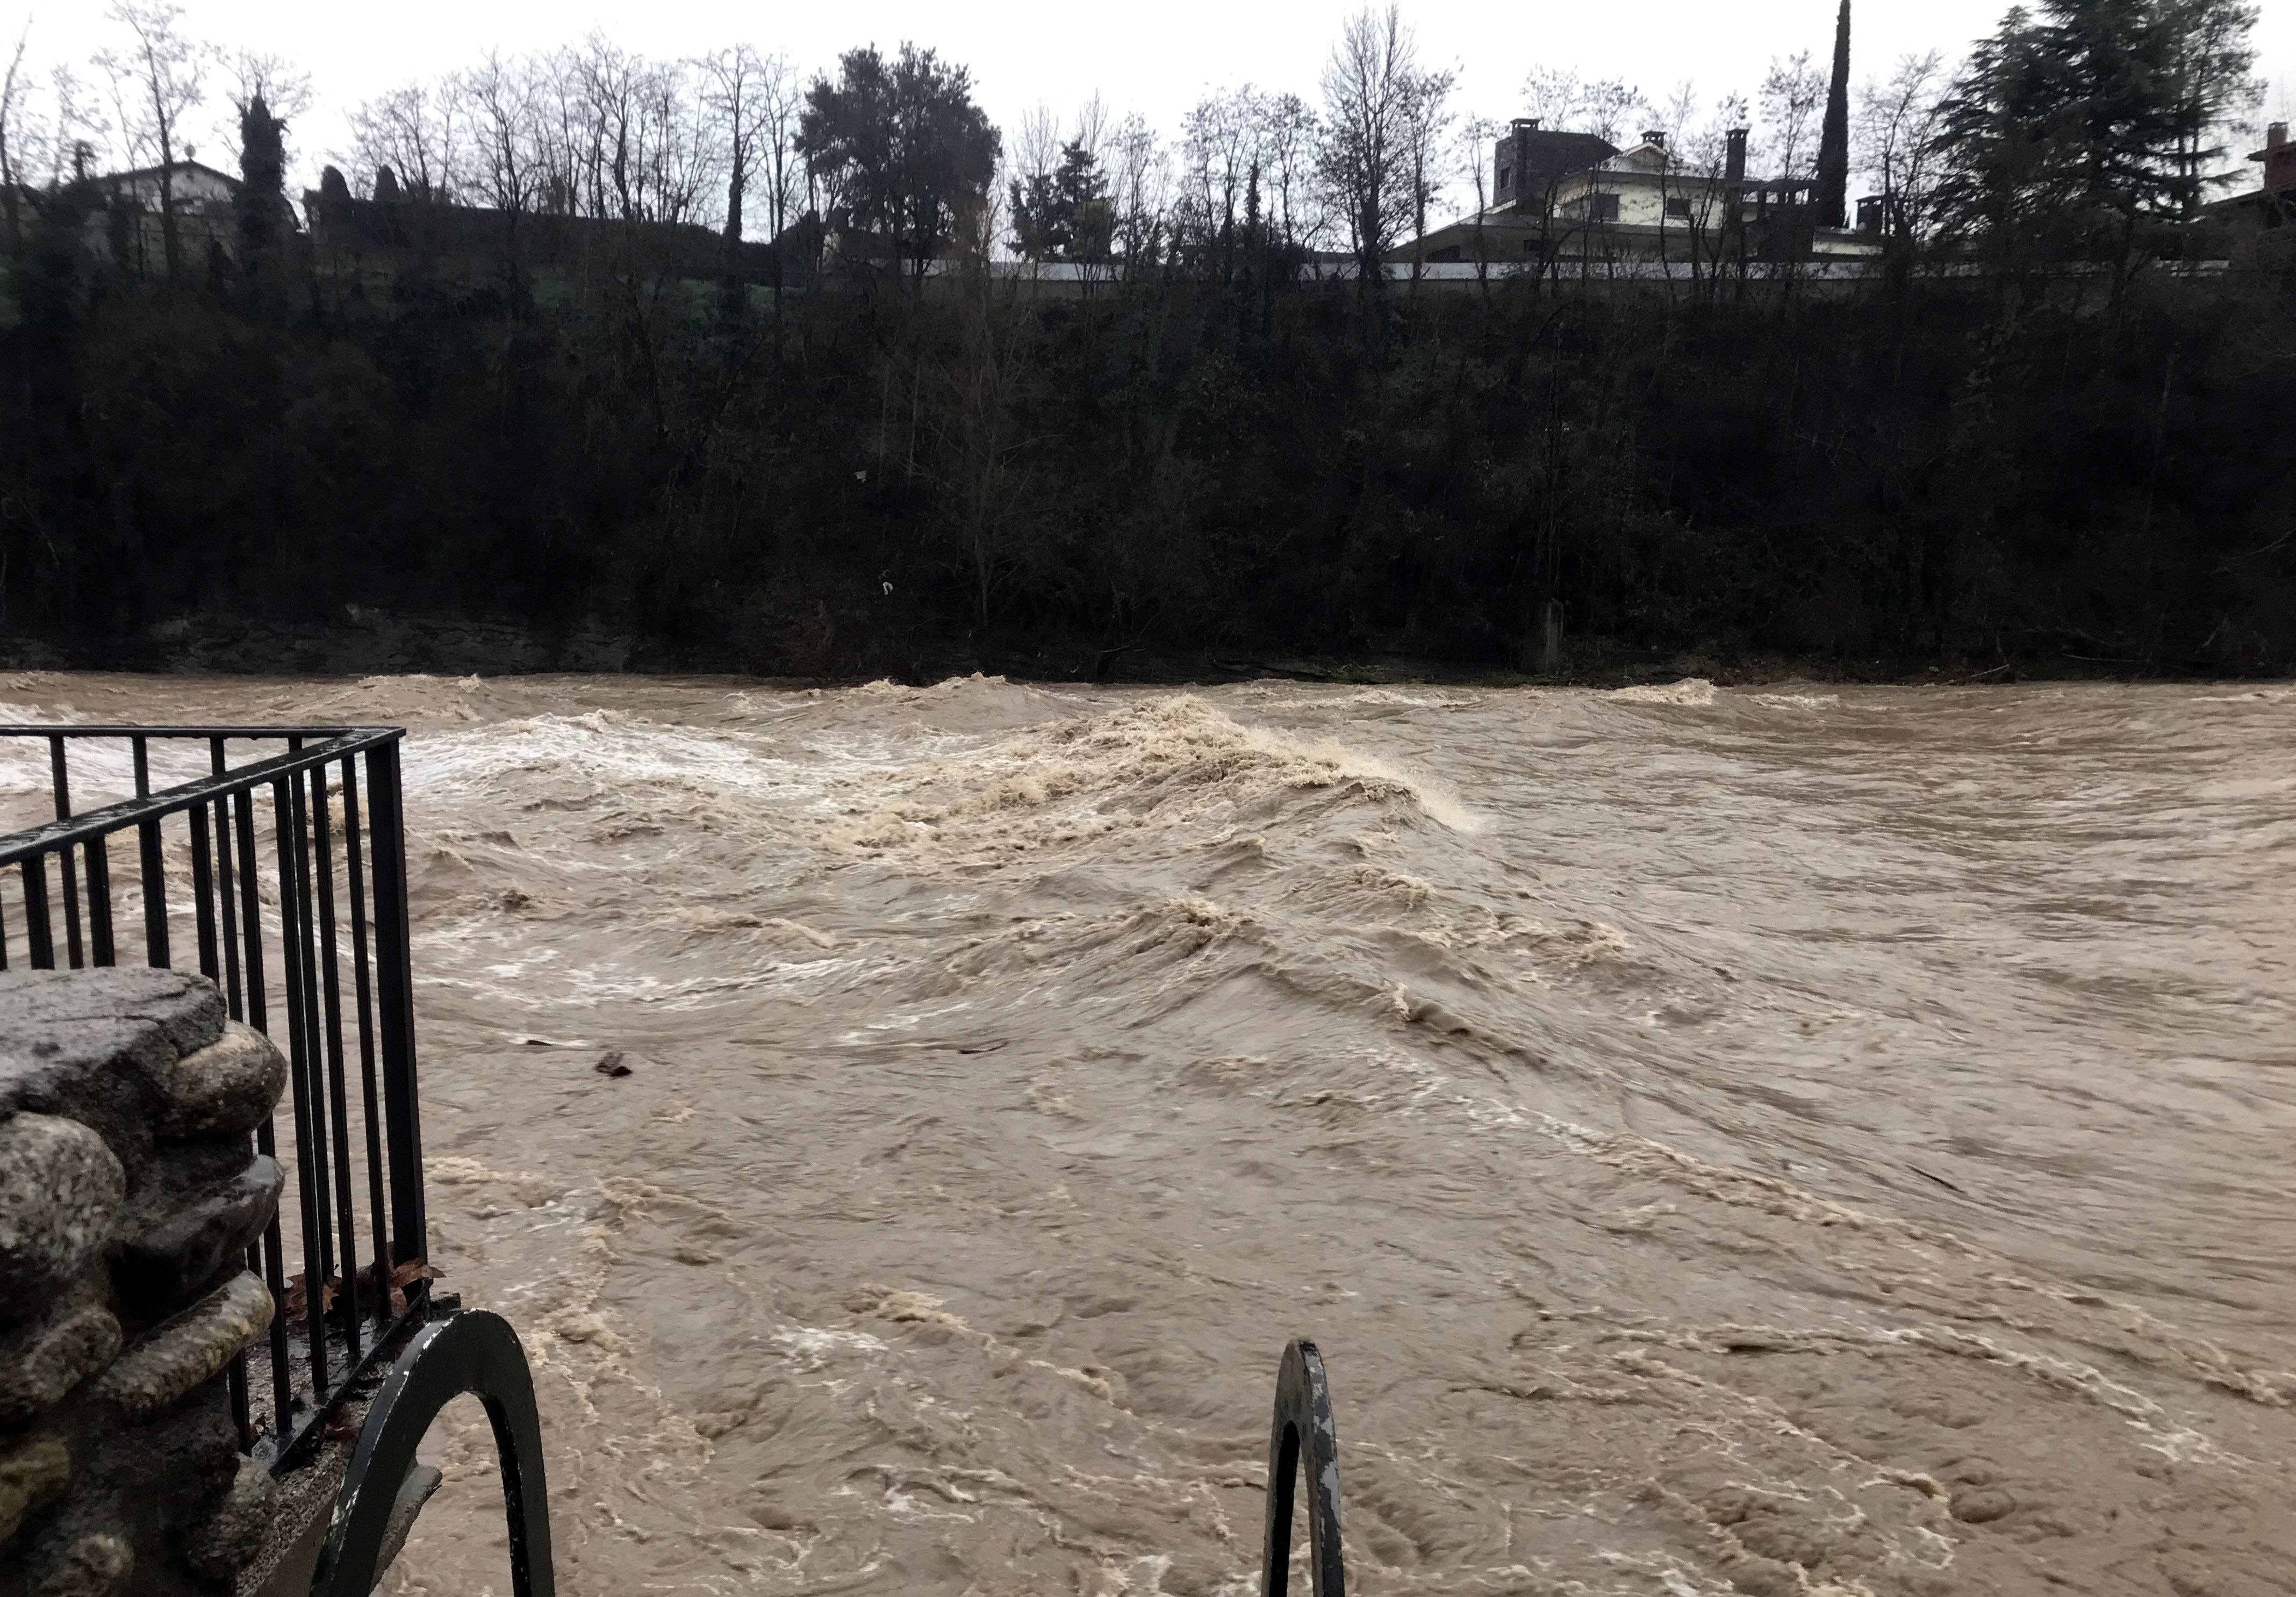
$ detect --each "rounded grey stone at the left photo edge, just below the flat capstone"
[0,1115,126,1319]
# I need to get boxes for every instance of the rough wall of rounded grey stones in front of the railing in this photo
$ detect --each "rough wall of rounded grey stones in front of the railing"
[0,968,287,1597]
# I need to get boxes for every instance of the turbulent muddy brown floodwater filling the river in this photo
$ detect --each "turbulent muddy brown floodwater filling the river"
[0,677,2296,1597]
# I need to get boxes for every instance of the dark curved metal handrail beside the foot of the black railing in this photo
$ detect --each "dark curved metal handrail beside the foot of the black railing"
[310,1310,556,1597]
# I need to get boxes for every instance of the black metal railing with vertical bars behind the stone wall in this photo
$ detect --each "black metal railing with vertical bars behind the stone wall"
[0,725,427,1469]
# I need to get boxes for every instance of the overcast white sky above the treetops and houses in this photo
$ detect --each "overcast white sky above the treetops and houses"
[0,0,2296,205]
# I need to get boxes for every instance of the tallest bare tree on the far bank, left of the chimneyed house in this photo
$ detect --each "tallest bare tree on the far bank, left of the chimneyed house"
[1323,5,1419,284]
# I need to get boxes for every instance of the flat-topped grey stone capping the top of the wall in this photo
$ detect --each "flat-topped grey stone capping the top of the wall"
[0,966,223,1168]
